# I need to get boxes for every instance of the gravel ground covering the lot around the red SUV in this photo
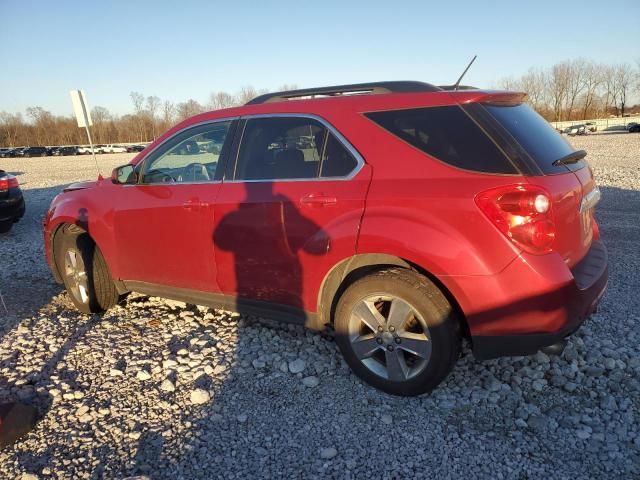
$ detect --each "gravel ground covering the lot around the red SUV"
[0,134,640,479]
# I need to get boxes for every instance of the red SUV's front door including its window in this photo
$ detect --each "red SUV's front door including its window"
[113,121,231,292]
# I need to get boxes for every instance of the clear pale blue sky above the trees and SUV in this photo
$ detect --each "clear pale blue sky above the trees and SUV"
[0,0,640,114]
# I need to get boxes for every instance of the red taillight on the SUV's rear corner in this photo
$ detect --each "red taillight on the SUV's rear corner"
[475,185,556,255]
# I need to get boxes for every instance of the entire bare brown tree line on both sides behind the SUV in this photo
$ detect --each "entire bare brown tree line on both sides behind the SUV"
[0,59,640,147]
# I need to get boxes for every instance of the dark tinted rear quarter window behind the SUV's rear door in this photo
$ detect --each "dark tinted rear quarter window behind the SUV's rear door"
[366,106,518,174]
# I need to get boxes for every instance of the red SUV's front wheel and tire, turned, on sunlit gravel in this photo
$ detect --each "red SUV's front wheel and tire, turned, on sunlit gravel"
[54,225,119,313]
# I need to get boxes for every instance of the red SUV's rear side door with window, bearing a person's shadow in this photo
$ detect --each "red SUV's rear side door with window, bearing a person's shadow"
[214,115,371,311]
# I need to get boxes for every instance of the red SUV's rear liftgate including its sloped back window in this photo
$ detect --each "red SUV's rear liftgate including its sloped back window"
[484,104,599,267]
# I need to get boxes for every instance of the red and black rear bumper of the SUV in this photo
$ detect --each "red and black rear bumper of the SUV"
[448,240,609,359]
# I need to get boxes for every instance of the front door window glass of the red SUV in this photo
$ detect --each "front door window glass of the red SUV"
[141,121,231,184]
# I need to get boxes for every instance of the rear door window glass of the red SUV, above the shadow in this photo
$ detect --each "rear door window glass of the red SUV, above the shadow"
[234,117,358,180]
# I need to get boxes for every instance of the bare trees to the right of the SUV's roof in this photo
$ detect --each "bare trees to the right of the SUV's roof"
[497,58,640,121]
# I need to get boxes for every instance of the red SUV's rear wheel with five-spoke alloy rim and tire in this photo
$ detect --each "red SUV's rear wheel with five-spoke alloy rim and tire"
[334,268,461,396]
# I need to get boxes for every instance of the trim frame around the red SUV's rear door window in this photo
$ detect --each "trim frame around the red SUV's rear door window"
[223,113,365,183]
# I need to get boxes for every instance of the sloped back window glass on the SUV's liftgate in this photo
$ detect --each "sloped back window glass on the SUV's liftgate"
[485,104,584,173]
